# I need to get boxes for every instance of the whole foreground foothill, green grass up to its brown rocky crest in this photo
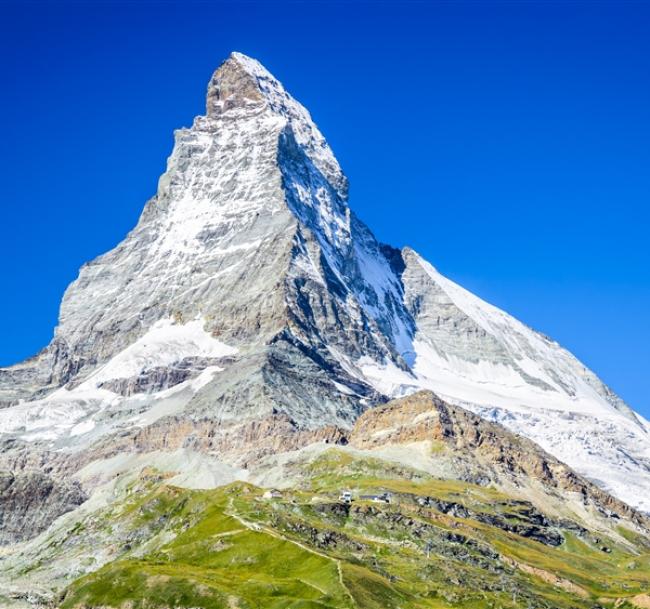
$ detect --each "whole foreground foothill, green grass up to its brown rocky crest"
[0,392,650,609]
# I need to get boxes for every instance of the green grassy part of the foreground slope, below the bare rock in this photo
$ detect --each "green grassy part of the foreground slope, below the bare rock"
[60,450,650,609]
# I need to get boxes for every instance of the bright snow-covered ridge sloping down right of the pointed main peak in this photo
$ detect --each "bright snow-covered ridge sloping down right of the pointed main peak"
[354,249,650,510]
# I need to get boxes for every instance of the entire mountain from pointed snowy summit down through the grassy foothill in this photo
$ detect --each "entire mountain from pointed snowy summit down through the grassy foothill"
[0,53,650,608]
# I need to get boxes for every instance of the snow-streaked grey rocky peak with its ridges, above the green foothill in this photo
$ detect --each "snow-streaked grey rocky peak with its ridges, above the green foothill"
[0,47,650,552]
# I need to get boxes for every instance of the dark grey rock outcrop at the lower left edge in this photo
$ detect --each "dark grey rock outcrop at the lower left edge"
[0,472,86,545]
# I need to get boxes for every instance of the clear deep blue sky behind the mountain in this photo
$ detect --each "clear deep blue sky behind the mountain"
[0,1,650,417]
